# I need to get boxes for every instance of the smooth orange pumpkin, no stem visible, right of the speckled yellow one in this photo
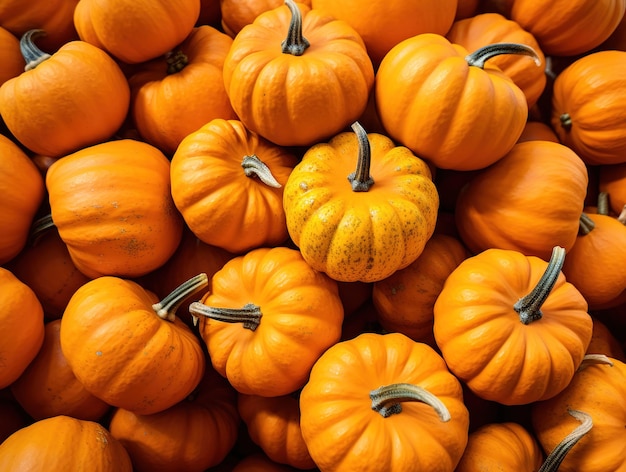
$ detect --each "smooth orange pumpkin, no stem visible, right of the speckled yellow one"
[455,141,588,260]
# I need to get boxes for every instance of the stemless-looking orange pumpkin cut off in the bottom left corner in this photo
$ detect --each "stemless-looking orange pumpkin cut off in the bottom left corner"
[0,415,133,472]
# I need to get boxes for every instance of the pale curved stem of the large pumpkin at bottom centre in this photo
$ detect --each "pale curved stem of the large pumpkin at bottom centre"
[370,383,450,422]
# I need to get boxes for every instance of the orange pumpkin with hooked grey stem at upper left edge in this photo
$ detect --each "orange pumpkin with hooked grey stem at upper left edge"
[0,30,130,157]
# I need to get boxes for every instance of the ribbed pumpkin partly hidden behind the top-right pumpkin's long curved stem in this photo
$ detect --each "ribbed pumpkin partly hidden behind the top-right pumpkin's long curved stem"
[446,13,547,108]
